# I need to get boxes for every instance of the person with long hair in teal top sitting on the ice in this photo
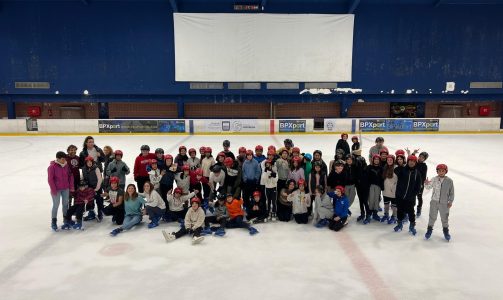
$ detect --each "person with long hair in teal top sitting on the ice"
[110,184,145,236]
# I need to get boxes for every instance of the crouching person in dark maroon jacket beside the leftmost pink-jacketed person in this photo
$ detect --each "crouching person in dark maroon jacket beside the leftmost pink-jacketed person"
[61,180,95,230]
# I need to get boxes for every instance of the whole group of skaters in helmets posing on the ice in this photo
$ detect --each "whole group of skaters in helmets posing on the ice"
[48,133,454,243]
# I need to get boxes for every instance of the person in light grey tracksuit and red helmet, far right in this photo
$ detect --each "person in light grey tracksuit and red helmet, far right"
[424,164,454,241]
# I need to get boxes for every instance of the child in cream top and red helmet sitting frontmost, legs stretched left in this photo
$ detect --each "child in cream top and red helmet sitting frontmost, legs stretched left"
[162,197,205,244]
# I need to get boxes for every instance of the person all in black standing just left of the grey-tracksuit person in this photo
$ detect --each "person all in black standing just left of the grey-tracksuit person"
[394,155,423,235]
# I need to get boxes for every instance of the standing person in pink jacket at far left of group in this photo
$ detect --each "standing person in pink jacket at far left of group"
[47,151,75,231]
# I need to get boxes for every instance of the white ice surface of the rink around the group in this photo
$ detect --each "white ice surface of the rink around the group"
[0,134,503,300]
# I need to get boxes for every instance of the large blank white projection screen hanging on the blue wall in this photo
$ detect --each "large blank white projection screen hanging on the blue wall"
[174,13,354,82]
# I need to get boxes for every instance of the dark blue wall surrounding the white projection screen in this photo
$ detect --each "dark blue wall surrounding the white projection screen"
[0,0,503,100]
